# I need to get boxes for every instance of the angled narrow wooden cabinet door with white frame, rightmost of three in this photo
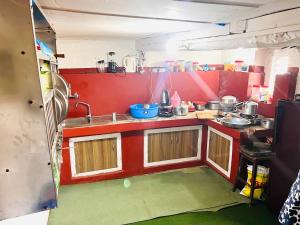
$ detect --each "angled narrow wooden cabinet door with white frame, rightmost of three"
[206,127,233,177]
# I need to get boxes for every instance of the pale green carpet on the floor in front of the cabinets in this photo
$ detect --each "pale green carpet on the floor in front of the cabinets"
[48,167,246,225]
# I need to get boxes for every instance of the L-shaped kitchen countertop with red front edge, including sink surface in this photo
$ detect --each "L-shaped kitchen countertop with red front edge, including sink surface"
[63,112,272,139]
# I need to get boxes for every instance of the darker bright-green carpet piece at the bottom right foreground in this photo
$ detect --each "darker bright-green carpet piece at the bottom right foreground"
[130,204,280,225]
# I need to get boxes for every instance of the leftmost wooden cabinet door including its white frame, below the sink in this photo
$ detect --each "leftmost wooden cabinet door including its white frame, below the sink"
[70,134,122,177]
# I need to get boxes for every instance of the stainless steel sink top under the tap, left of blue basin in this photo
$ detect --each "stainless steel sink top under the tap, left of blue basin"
[62,114,131,128]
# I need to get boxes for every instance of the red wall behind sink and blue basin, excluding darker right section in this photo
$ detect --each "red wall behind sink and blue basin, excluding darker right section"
[61,70,219,117]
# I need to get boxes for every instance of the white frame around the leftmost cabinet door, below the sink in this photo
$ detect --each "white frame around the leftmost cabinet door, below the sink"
[69,133,122,177]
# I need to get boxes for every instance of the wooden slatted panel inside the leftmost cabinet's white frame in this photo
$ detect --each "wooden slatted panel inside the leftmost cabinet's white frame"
[74,138,117,174]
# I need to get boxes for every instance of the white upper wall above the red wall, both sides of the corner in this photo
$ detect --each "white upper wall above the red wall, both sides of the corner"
[57,39,300,93]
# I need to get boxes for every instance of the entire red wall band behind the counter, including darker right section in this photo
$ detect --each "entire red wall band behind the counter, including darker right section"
[60,67,270,118]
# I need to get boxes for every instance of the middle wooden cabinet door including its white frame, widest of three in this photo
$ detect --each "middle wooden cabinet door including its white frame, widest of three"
[144,126,202,167]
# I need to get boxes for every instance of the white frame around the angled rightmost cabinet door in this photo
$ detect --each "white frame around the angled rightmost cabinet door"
[206,127,233,178]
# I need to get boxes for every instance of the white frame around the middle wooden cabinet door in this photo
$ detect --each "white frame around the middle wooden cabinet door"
[144,125,202,167]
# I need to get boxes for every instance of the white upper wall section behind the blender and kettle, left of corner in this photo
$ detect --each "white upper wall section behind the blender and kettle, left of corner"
[56,39,135,68]
